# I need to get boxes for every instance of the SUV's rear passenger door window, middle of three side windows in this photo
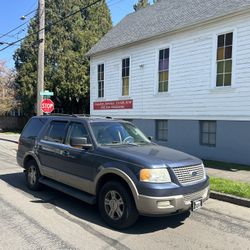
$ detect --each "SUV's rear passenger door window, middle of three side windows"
[44,121,67,143]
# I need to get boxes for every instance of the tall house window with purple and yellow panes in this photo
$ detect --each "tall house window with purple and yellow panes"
[158,49,169,92]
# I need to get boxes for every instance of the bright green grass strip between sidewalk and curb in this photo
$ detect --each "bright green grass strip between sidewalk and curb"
[210,177,250,199]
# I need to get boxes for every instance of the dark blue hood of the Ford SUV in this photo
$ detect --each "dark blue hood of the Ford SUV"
[98,143,202,168]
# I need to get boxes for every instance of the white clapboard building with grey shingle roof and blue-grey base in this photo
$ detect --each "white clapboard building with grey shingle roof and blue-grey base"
[88,0,250,164]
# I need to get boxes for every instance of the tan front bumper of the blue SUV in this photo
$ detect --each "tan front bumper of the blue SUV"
[136,186,210,216]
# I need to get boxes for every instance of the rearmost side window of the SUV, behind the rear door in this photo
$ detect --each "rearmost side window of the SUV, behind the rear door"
[22,118,47,139]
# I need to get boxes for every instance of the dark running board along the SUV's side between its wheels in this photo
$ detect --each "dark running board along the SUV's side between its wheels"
[39,177,96,205]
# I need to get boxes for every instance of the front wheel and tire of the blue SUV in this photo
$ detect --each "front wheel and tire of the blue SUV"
[98,181,138,229]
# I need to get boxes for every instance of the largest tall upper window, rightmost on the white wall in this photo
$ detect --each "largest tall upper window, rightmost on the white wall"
[216,32,233,87]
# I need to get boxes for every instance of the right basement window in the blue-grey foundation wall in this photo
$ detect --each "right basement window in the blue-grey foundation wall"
[200,121,216,147]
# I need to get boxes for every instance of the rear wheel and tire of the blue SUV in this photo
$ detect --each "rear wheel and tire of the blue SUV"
[25,160,42,191]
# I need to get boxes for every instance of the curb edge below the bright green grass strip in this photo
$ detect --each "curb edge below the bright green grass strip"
[210,191,250,208]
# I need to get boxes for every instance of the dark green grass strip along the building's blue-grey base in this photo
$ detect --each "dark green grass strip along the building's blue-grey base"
[203,160,250,171]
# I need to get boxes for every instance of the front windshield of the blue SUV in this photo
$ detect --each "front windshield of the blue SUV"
[90,122,150,145]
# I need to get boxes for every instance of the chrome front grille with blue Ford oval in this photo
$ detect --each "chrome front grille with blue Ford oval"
[173,164,205,184]
